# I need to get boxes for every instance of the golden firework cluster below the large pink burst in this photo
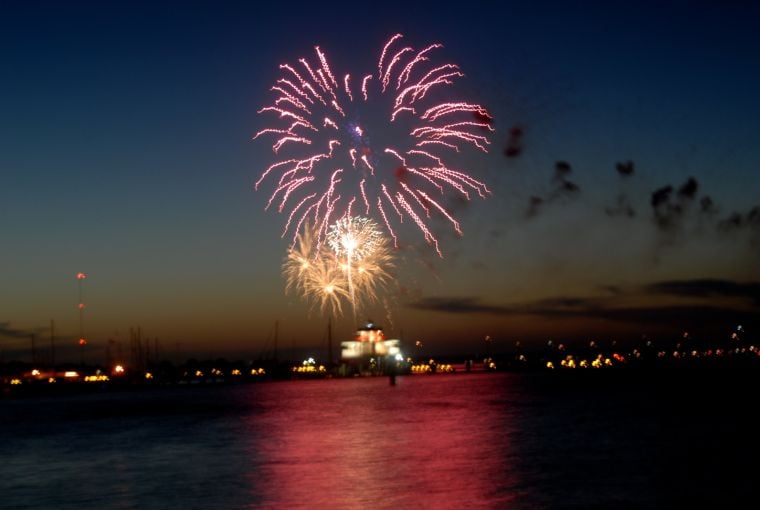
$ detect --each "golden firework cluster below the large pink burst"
[283,217,393,316]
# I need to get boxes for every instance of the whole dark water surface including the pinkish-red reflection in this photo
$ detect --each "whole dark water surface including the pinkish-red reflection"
[0,372,760,510]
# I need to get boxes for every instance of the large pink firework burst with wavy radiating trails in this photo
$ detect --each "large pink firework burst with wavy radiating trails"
[254,34,493,255]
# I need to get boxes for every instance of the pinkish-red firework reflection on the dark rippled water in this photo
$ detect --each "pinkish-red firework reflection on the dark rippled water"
[250,375,519,508]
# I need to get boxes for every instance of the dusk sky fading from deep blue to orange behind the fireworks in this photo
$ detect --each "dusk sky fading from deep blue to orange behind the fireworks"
[0,1,760,361]
